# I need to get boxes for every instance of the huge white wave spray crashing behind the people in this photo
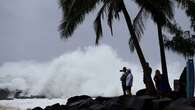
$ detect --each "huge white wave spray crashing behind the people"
[0,45,187,98]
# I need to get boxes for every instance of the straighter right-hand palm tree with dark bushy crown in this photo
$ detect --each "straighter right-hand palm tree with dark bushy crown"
[135,0,173,92]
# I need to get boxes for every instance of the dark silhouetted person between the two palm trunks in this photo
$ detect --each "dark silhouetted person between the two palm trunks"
[154,70,161,91]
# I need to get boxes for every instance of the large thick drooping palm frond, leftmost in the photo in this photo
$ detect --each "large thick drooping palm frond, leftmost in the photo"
[59,0,99,39]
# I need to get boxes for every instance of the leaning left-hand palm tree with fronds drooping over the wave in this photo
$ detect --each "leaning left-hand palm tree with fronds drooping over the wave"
[60,0,156,95]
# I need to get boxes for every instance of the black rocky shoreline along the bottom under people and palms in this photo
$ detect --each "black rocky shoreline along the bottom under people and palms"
[32,95,195,110]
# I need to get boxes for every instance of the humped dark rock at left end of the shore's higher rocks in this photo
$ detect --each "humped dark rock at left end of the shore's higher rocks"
[66,95,92,105]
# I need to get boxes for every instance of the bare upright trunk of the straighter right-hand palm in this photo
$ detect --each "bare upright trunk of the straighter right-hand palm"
[157,23,171,92]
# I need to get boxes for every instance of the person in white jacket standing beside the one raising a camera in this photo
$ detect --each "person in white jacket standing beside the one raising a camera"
[126,69,133,96]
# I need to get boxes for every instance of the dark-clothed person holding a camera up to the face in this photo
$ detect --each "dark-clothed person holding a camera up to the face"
[120,67,127,95]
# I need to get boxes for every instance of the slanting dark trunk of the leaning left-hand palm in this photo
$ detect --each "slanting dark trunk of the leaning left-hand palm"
[121,1,156,95]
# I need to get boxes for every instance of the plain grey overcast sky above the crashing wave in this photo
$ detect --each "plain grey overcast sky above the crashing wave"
[0,0,194,68]
